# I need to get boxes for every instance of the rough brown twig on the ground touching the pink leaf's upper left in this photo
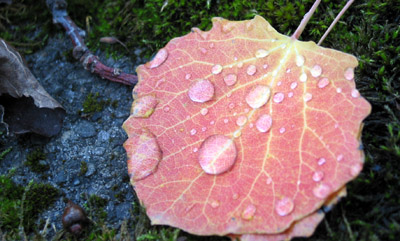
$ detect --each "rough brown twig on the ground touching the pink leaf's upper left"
[46,0,137,85]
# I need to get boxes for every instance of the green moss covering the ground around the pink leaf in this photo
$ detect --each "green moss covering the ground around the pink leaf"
[0,0,400,240]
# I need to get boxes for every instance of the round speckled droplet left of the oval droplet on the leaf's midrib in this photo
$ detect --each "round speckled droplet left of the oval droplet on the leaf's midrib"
[188,79,214,103]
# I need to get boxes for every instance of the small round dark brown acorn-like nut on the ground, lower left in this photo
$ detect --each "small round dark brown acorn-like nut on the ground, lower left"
[62,200,89,236]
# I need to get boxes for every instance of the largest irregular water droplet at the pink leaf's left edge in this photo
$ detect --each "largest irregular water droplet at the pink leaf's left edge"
[124,129,162,182]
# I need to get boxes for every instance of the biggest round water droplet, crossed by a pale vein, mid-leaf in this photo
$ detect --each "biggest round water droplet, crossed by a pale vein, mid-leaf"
[199,135,237,175]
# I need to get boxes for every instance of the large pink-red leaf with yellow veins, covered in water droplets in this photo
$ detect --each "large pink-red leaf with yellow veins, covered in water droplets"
[123,16,371,238]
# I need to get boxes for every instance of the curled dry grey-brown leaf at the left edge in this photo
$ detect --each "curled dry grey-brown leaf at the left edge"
[0,39,65,136]
